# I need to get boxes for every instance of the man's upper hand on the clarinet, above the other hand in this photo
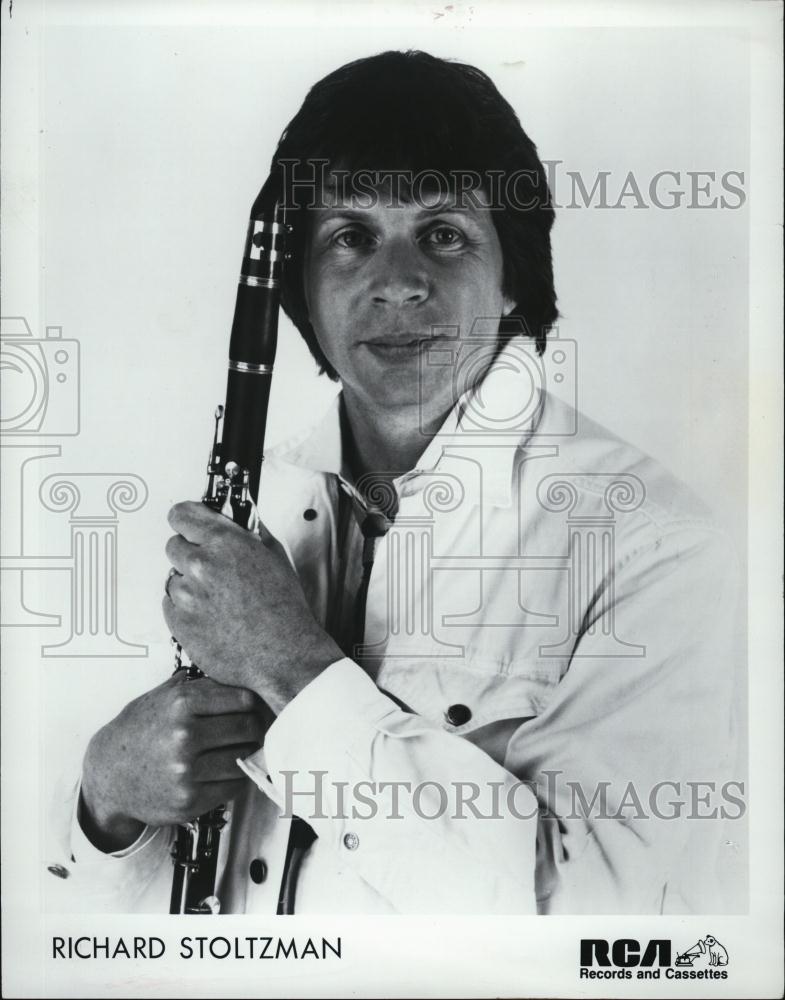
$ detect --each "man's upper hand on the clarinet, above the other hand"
[163,503,343,714]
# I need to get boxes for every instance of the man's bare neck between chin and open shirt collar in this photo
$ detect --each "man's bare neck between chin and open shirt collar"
[341,389,446,479]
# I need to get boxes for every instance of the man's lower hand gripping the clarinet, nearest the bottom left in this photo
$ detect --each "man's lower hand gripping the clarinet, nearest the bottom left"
[79,675,272,852]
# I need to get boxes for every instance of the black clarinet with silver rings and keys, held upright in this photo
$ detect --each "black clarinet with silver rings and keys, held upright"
[169,174,292,914]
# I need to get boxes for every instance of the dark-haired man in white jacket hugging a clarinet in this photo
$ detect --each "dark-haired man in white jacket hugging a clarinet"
[46,52,734,913]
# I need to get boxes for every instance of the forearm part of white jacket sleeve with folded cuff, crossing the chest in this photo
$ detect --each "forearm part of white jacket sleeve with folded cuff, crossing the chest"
[238,659,537,913]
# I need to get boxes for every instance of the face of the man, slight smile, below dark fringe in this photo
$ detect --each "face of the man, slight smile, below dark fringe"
[305,186,514,424]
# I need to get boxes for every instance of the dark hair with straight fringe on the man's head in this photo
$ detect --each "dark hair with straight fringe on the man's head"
[272,51,558,378]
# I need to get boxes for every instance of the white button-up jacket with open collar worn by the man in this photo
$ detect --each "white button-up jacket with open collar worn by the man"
[46,350,743,914]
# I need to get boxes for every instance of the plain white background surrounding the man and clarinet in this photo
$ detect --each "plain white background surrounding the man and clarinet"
[2,0,779,995]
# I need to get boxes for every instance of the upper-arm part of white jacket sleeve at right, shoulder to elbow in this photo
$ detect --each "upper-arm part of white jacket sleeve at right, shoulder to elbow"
[505,523,744,913]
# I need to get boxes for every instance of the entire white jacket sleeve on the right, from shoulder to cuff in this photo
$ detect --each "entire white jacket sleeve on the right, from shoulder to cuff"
[243,525,739,913]
